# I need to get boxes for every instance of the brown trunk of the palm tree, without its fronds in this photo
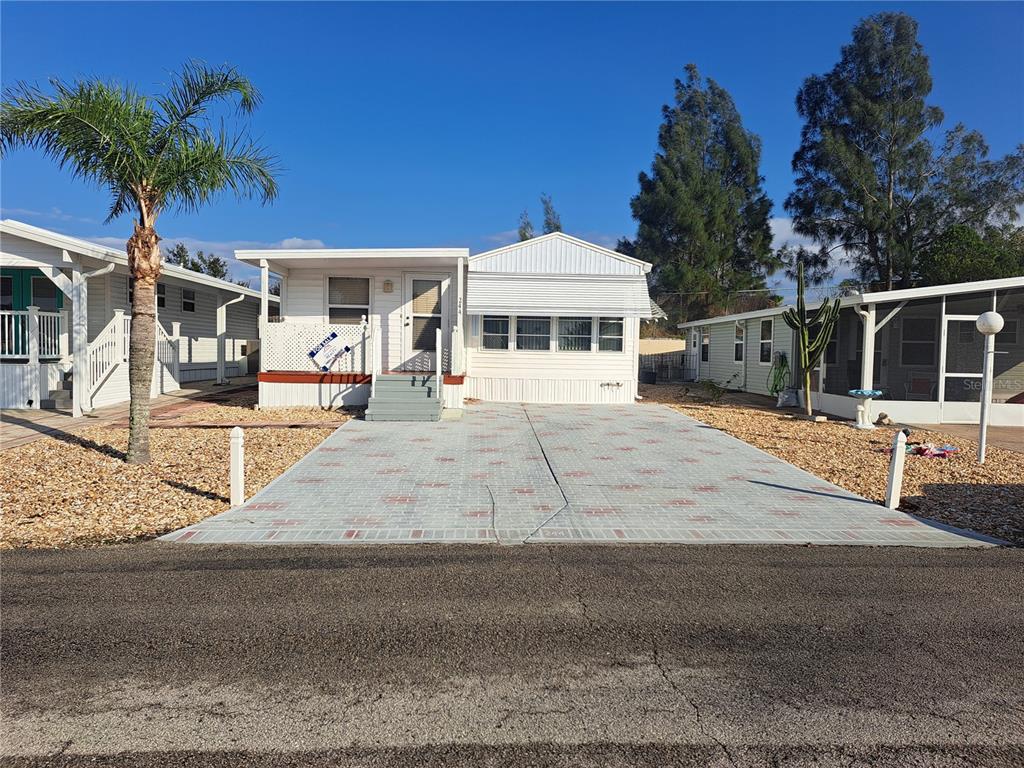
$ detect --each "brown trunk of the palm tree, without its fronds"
[127,224,160,464]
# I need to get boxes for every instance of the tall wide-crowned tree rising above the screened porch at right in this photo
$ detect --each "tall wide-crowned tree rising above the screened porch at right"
[785,13,1024,288]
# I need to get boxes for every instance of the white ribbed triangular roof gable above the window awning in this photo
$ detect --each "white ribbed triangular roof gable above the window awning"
[469,232,650,274]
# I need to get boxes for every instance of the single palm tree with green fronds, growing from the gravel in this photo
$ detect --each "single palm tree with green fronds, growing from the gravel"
[0,62,278,464]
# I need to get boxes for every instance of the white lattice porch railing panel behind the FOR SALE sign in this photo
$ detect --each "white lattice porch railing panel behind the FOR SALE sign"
[260,322,379,374]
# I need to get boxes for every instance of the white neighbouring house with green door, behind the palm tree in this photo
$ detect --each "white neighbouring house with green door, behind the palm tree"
[0,220,276,416]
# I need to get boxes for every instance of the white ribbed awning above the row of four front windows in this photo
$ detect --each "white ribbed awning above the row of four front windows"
[466,271,651,317]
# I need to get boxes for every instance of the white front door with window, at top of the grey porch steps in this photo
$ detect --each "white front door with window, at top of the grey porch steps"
[392,272,450,371]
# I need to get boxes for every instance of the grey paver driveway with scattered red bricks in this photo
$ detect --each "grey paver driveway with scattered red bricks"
[164,403,988,547]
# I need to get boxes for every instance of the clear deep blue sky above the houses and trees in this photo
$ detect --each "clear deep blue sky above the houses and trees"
[0,2,1024,290]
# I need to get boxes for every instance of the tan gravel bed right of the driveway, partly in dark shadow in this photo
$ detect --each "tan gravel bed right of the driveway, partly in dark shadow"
[640,384,1024,545]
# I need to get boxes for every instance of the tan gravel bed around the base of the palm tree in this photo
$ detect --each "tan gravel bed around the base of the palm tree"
[0,391,350,549]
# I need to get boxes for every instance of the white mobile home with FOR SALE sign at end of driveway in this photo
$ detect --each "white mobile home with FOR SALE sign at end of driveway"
[236,232,651,419]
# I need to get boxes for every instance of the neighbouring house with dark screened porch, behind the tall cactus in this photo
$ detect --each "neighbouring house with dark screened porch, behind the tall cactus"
[679,278,1024,427]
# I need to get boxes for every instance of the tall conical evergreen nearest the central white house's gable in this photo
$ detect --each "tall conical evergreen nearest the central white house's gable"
[631,65,778,319]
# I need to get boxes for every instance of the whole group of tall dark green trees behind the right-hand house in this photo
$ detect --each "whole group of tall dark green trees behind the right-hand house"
[618,13,1024,321]
